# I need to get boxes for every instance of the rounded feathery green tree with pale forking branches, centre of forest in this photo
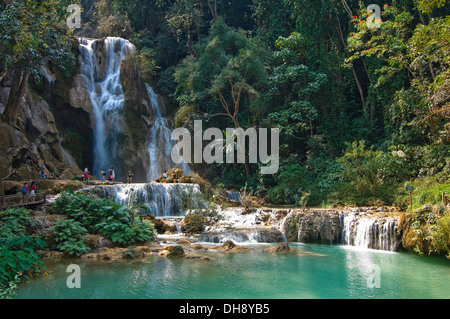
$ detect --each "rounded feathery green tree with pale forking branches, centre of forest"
[175,18,267,175]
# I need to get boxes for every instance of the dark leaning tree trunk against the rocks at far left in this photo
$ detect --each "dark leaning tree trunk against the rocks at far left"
[3,68,30,125]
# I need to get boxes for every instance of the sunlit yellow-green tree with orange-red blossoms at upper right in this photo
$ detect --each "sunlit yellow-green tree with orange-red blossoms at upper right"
[346,1,450,138]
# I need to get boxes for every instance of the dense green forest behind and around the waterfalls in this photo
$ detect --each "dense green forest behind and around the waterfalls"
[0,0,450,208]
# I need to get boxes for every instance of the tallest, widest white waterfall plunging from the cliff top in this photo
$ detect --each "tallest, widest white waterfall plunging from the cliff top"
[79,37,134,176]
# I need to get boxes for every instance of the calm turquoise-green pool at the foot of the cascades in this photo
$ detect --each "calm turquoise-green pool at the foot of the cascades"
[17,244,450,299]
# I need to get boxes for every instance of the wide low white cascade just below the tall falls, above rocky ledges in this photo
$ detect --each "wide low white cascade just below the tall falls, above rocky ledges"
[95,183,202,217]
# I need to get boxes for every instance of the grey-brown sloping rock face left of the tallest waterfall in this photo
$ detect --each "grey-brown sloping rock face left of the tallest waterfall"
[0,71,81,184]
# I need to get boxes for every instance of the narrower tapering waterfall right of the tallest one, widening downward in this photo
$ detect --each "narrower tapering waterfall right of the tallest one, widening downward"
[146,84,191,182]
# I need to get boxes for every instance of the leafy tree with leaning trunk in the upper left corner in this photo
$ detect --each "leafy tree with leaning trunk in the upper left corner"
[0,0,74,125]
